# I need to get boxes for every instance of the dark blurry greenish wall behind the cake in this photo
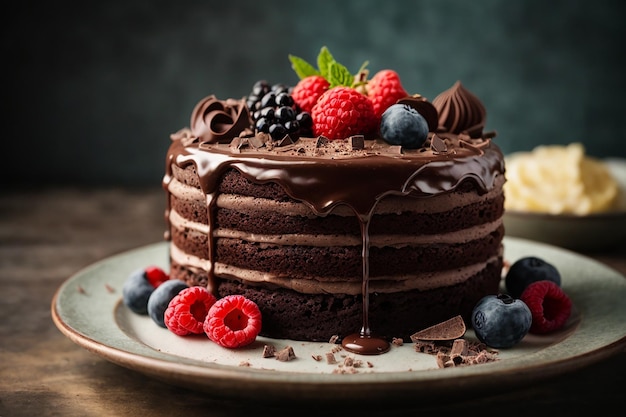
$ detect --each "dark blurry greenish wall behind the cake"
[0,0,626,187]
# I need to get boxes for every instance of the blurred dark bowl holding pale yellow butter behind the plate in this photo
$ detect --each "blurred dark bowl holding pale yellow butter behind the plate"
[504,158,626,252]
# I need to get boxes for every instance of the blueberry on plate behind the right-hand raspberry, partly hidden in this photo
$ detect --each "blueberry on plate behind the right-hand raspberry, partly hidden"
[504,256,561,298]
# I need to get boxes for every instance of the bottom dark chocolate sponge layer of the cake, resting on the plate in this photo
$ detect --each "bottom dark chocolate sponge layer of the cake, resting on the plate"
[210,258,502,342]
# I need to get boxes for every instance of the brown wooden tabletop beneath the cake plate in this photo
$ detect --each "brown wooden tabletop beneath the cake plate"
[0,188,626,417]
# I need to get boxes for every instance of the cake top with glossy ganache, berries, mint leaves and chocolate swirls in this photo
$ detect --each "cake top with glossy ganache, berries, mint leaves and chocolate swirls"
[164,48,504,219]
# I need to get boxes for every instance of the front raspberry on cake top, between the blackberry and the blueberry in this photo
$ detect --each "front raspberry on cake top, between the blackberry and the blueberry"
[311,87,378,139]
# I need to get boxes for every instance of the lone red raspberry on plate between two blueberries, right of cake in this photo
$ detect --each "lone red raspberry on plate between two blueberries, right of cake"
[520,280,572,334]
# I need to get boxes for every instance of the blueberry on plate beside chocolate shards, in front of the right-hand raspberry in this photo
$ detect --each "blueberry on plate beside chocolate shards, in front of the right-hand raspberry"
[471,294,532,349]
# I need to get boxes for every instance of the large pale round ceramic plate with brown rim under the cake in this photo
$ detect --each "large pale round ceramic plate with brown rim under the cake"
[52,238,626,403]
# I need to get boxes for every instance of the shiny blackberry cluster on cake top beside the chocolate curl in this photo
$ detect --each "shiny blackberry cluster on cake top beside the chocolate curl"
[246,80,313,140]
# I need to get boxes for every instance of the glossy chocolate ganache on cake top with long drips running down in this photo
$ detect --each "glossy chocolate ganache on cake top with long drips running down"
[163,89,504,354]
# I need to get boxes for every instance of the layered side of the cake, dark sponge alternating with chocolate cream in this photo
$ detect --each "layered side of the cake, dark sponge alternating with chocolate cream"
[167,132,504,341]
